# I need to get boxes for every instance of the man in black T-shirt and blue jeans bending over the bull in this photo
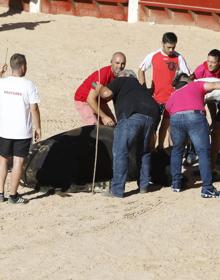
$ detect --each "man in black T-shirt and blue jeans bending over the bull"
[88,70,160,198]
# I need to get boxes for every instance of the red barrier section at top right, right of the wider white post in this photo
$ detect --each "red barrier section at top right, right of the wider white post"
[139,0,220,31]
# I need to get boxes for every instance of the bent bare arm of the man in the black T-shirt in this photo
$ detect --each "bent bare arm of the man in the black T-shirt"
[86,85,115,126]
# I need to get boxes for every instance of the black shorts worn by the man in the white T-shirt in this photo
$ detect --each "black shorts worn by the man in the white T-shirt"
[0,137,31,157]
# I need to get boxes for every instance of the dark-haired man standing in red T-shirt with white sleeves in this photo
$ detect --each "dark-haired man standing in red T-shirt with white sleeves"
[138,32,190,149]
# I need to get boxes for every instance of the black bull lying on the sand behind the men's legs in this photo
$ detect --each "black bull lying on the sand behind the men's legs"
[22,126,170,190]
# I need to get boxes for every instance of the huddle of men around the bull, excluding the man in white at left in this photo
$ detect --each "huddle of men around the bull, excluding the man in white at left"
[74,32,220,198]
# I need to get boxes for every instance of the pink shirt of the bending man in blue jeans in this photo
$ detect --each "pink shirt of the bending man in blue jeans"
[166,81,206,115]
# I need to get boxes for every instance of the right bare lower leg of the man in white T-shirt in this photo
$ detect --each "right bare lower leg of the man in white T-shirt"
[10,156,24,195]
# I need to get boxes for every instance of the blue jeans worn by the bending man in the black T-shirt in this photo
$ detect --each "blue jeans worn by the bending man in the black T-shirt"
[111,114,153,197]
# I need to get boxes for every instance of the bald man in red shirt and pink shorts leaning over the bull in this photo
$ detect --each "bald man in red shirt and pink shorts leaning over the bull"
[74,52,126,125]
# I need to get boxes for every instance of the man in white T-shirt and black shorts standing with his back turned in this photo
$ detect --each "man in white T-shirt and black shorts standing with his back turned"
[0,54,41,203]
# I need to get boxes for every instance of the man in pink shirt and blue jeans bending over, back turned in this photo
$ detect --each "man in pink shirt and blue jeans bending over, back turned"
[166,73,220,198]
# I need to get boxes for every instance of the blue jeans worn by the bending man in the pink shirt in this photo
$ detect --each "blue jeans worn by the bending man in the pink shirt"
[170,112,213,190]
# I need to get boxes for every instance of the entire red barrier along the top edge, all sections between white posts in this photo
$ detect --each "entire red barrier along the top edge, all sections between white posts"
[0,0,220,30]
